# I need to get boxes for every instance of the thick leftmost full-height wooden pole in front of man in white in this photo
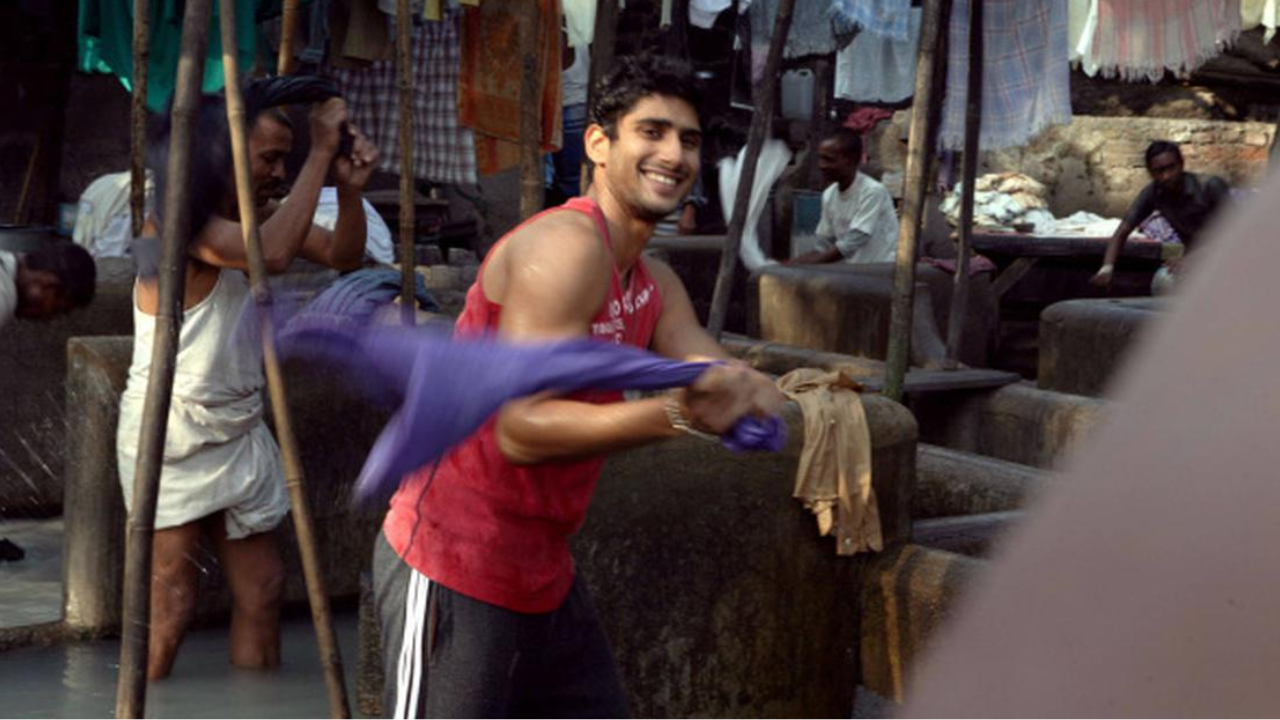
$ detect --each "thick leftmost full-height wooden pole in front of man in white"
[115,0,210,717]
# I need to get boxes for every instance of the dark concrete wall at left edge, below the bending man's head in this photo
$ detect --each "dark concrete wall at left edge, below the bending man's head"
[0,259,133,518]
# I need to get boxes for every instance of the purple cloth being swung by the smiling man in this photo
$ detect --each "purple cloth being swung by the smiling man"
[280,318,786,500]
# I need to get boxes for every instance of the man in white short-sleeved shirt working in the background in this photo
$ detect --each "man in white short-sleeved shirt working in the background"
[787,128,897,265]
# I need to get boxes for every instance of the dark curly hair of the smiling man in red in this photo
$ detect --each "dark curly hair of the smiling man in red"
[591,53,700,138]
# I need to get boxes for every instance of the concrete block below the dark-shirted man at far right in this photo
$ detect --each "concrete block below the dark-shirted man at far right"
[1036,297,1166,397]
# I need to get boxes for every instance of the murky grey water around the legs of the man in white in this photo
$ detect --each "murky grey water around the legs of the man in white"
[0,611,356,717]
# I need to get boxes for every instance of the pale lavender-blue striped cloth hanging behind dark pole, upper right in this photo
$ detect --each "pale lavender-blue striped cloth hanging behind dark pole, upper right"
[938,0,1071,150]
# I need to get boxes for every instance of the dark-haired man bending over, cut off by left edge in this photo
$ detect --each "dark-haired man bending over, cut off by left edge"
[0,242,97,328]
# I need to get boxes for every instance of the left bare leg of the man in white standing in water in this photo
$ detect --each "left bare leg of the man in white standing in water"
[147,521,200,680]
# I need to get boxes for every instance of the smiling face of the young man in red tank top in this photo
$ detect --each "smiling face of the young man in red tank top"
[596,95,703,222]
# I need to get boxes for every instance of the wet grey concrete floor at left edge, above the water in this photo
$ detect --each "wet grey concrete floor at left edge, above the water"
[0,518,63,627]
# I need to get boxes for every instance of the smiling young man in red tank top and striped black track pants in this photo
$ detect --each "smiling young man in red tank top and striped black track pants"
[374,56,782,717]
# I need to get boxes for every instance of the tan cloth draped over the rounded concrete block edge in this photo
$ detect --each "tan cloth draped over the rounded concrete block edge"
[778,368,883,555]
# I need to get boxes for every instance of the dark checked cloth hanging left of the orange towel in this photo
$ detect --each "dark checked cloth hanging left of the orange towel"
[328,10,476,184]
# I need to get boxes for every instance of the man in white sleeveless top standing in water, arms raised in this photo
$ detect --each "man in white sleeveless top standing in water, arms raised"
[116,78,378,679]
